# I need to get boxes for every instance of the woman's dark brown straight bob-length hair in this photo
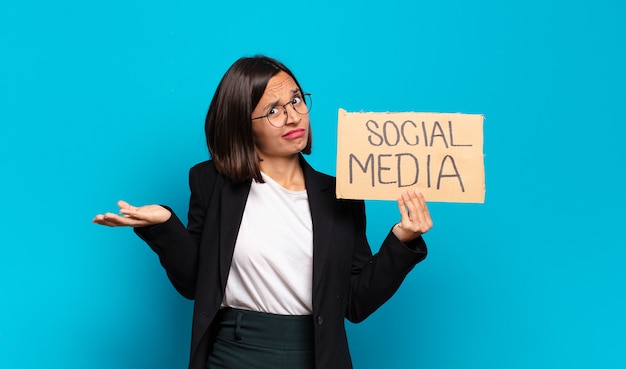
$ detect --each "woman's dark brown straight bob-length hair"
[204,55,312,183]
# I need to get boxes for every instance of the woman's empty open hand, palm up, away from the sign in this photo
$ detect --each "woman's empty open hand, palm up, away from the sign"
[93,200,172,227]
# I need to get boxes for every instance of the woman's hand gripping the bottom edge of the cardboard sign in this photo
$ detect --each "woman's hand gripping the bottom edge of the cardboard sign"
[392,190,433,242]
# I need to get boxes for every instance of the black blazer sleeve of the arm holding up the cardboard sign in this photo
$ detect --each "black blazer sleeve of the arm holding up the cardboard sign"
[346,201,427,323]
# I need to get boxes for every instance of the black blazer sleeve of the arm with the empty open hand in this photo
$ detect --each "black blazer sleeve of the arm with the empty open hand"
[134,164,215,299]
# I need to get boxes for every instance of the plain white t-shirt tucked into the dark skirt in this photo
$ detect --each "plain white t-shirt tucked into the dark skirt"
[222,173,313,315]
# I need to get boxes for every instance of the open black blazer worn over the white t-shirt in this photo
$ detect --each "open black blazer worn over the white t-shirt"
[135,157,426,369]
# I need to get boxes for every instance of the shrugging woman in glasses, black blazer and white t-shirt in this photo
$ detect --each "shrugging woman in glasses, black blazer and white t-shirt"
[94,56,432,369]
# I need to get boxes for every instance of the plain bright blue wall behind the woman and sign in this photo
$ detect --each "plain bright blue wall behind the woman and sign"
[0,0,626,369]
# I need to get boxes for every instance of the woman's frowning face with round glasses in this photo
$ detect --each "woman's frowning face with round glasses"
[251,72,309,160]
